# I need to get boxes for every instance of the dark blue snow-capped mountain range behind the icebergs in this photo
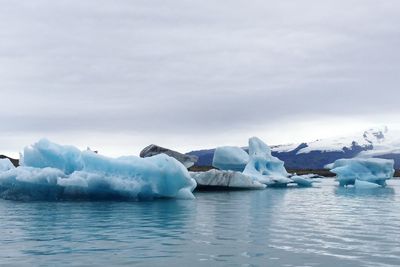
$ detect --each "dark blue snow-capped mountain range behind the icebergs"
[188,127,400,169]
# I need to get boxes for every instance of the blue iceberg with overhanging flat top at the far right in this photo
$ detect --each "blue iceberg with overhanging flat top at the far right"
[326,158,395,188]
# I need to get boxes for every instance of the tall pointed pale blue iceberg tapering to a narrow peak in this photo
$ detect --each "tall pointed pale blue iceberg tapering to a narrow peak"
[243,137,293,186]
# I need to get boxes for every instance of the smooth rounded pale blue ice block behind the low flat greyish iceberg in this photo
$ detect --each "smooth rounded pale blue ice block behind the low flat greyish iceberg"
[212,146,249,172]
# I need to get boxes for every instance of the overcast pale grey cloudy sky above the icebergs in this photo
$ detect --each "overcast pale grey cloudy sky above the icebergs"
[0,0,400,156]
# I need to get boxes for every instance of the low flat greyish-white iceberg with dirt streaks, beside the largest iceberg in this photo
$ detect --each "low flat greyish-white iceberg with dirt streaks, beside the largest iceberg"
[190,170,265,189]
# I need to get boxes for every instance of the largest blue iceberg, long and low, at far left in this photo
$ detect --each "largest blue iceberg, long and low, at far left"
[0,139,196,200]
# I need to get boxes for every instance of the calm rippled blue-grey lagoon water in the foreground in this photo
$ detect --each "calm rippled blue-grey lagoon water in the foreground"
[0,179,400,267]
